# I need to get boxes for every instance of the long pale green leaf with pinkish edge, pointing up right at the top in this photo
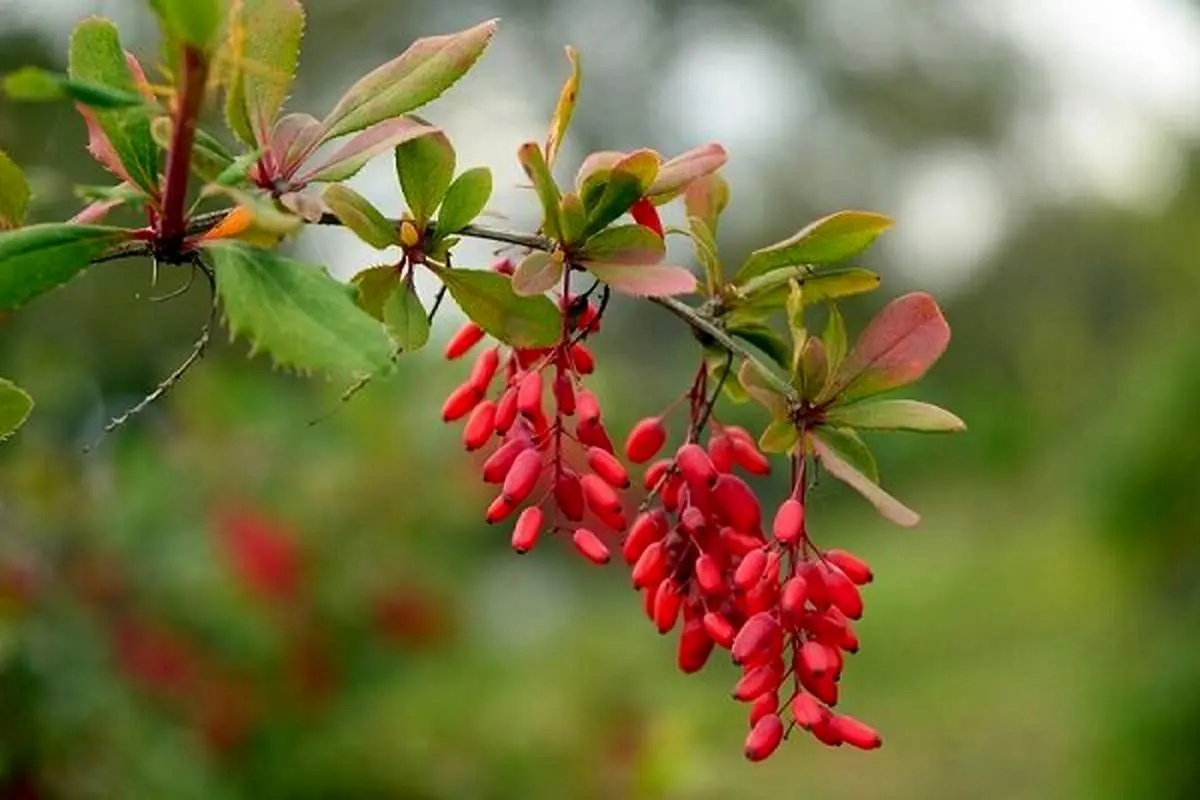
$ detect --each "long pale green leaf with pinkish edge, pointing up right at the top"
[323,19,499,140]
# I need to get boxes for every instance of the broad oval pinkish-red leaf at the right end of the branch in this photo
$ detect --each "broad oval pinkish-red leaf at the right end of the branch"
[821,291,950,402]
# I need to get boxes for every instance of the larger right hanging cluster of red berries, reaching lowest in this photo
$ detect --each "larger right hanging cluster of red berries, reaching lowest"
[622,417,881,760]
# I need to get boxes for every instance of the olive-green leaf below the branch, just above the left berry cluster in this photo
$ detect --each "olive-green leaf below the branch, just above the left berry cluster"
[428,264,563,348]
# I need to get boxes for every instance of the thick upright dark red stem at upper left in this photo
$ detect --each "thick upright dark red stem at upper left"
[158,44,209,249]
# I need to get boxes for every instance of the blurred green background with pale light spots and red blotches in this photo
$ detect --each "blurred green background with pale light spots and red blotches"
[0,0,1200,800]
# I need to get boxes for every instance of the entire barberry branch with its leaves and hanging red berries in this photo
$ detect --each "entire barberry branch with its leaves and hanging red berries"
[0,7,964,760]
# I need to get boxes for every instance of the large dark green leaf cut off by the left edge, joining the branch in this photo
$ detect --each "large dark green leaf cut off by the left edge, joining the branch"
[0,223,130,311]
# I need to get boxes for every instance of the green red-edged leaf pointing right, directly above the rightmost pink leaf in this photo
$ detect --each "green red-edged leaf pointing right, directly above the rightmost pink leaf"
[737,211,892,283]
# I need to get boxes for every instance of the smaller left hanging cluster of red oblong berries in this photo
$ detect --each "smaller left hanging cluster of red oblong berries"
[442,259,630,564]
